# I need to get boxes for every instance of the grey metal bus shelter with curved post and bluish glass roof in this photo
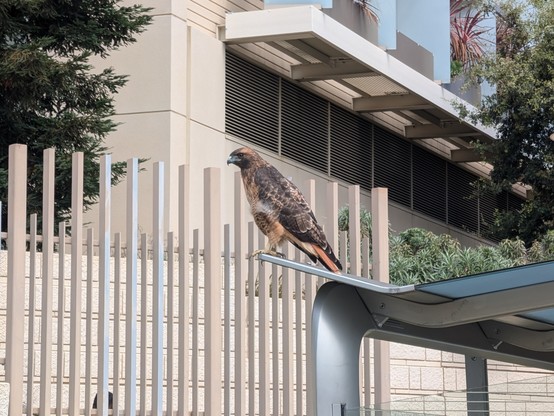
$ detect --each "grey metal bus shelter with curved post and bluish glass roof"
[260,255,554,416]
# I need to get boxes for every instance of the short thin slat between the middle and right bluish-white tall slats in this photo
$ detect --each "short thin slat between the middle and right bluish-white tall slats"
[140,233,148,416]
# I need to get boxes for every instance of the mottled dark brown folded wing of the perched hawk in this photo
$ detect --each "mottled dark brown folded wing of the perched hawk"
[256,166,342,272]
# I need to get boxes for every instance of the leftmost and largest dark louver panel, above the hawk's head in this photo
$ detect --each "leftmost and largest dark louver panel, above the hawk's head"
[225,53,279,152]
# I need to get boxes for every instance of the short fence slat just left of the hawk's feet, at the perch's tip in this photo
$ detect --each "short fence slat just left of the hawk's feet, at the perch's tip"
[247,222,254,415]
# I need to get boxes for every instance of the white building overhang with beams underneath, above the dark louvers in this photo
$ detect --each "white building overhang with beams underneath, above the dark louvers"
[221,6,495,163]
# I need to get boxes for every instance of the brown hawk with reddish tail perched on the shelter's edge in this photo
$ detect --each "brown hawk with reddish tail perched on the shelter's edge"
[227,147,342,273]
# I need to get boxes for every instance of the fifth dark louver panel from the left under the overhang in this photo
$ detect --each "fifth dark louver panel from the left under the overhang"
[412,146,446,222]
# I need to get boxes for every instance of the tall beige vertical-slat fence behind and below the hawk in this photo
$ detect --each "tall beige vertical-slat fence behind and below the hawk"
[0,145,371,416]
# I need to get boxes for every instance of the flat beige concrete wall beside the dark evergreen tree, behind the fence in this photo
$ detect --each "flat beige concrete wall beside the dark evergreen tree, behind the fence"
[85,0,188,237]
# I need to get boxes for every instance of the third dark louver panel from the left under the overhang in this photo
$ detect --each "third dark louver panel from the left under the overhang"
[331,105,373,190]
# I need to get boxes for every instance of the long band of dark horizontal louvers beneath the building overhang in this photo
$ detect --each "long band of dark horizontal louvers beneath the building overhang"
[226,53,512,238]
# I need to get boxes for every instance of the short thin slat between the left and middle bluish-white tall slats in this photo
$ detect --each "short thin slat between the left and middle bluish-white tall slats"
[112,233,121,415]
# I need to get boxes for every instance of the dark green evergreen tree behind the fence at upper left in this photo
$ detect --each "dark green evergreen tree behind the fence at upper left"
[0,0,151,231]
